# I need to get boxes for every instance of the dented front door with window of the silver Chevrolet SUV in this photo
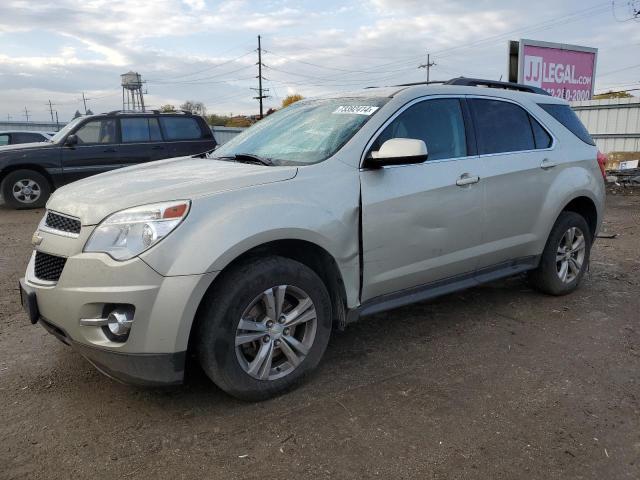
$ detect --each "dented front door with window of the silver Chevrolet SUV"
[361,98,484,302]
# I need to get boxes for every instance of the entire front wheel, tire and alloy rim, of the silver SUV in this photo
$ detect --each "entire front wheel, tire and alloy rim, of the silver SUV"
[196,256,331,401]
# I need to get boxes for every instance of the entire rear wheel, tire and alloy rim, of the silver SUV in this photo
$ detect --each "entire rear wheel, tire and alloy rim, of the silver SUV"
[529,212,592,295]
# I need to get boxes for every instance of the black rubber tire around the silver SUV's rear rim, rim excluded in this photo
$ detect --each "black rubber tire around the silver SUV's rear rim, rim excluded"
[529,212,593,295]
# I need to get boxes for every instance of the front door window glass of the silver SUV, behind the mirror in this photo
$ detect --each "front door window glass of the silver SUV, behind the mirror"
[372,98,467,160]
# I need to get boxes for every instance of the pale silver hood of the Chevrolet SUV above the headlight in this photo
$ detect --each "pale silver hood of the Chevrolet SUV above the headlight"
[47,157,298,225]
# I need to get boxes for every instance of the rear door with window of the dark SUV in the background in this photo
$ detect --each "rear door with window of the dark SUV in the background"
[119,116,165,167]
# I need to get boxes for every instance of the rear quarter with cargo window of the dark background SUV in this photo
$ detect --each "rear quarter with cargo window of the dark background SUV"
[160,115,215,157]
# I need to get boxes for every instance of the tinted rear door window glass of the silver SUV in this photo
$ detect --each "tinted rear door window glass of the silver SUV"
[469,98,535,155]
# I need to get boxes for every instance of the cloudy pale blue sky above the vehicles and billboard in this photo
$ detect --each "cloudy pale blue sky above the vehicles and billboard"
[0,0,640,121]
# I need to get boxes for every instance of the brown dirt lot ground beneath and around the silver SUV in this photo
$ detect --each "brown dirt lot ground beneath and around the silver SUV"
[0,196,640,479]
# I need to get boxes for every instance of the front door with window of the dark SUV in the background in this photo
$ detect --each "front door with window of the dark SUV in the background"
[62,118,120,183]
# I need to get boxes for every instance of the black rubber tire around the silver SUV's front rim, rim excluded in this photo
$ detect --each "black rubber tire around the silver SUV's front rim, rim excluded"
[195,256,332,401]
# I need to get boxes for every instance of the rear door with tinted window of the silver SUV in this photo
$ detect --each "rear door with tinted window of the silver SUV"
[467,97,558,268]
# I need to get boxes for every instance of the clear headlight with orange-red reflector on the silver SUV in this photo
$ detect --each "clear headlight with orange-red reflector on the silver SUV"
[84,200,190,260]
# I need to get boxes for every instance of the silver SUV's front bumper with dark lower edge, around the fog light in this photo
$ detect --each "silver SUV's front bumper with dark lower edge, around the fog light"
[22,252,215,385]
